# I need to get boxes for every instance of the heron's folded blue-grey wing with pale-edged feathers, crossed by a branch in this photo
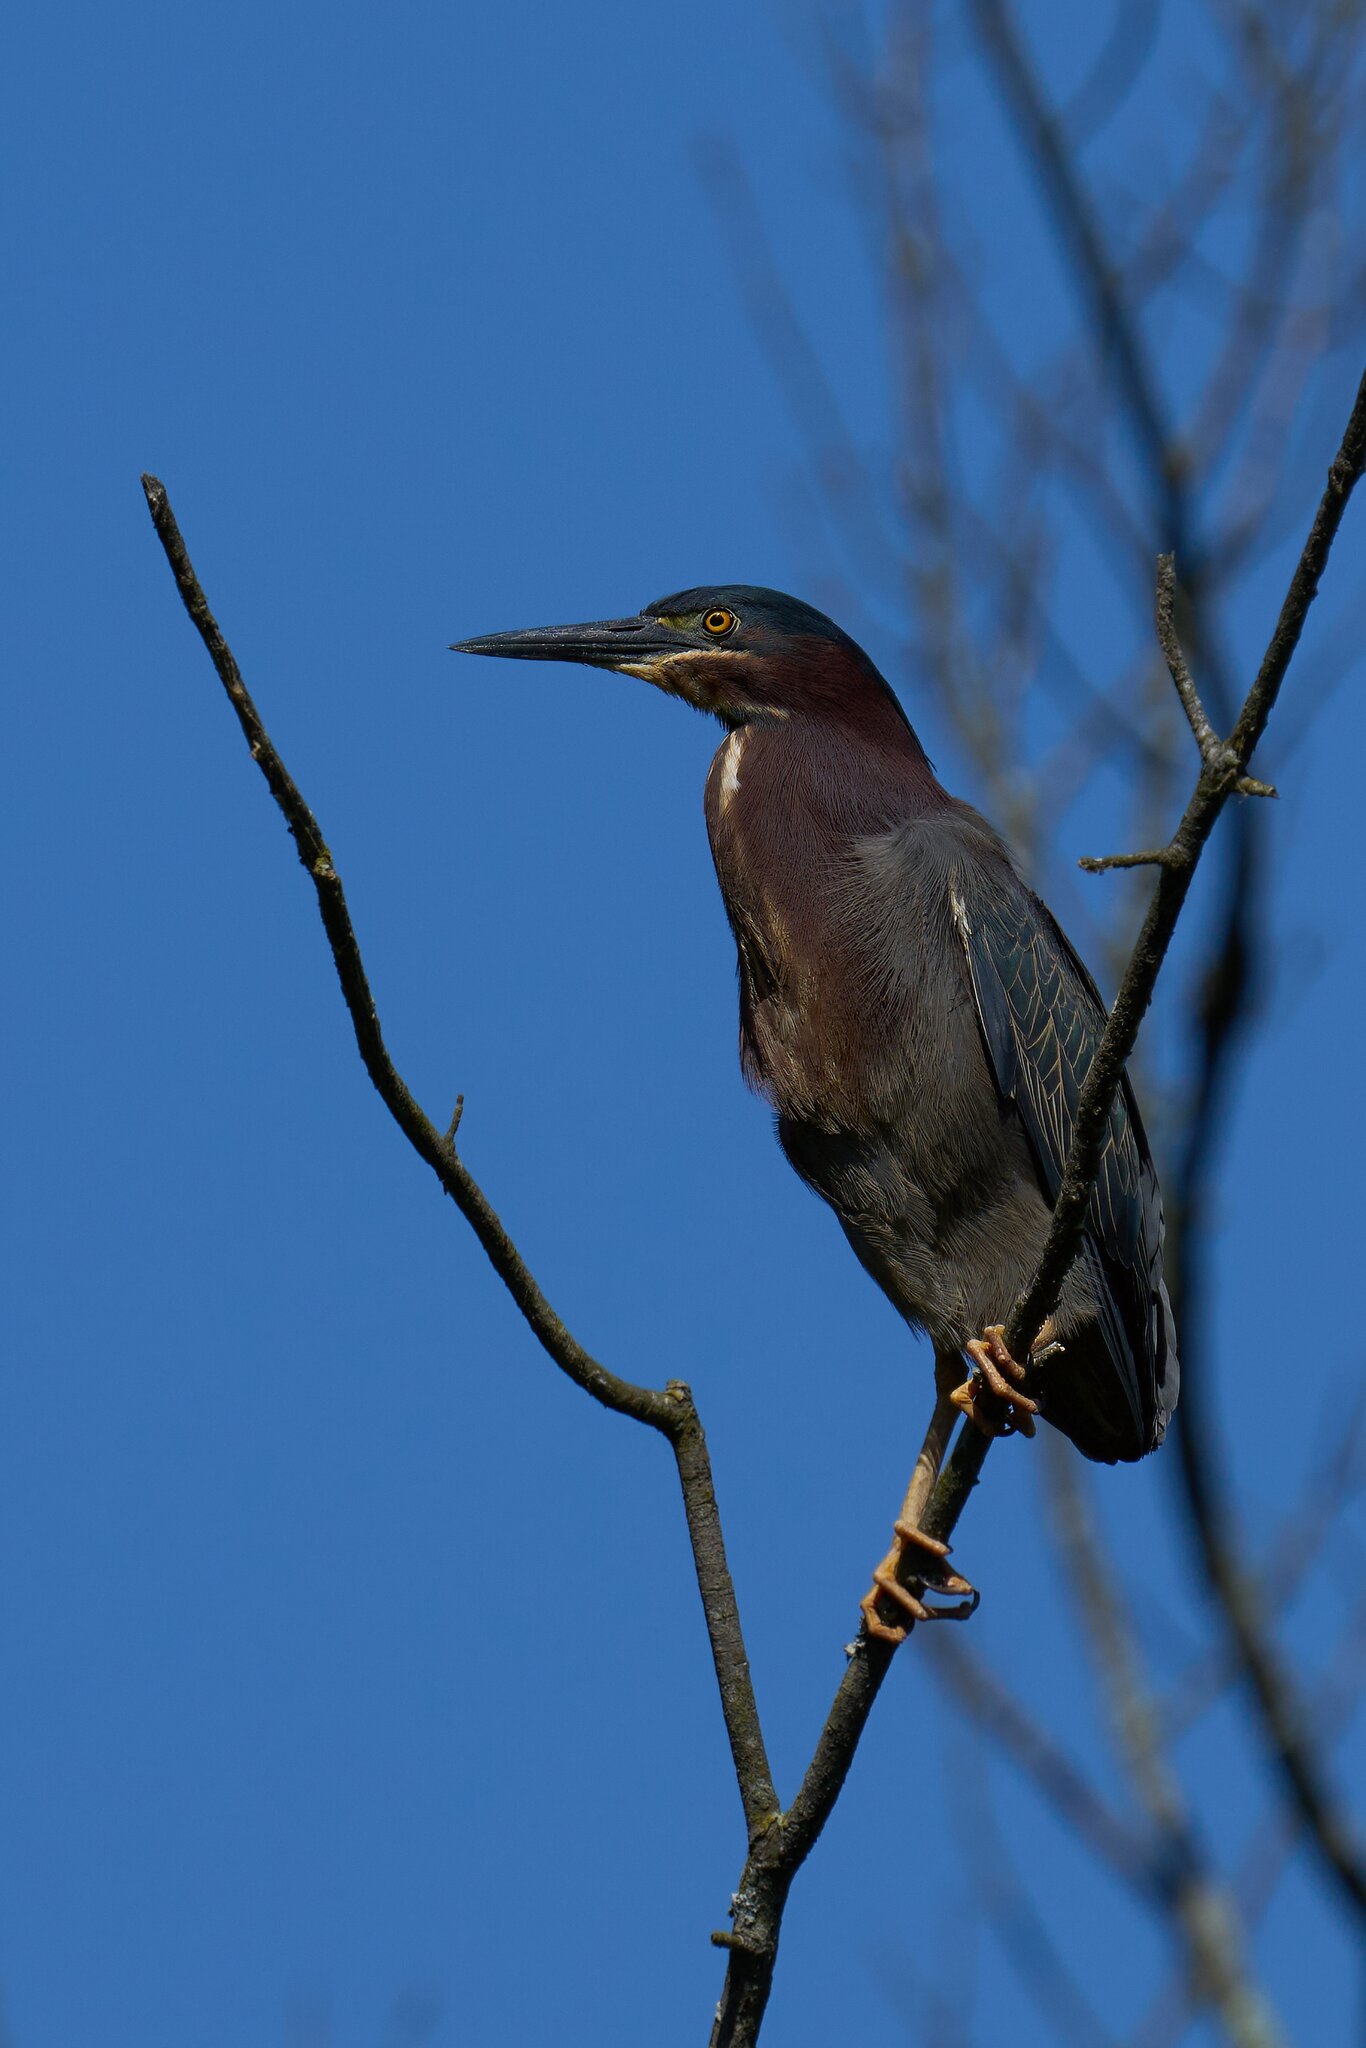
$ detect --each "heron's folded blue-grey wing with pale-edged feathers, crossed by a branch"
[950,870,1167,1450]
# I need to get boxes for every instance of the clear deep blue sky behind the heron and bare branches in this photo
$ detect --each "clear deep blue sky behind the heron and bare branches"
[0,0,1366,2048]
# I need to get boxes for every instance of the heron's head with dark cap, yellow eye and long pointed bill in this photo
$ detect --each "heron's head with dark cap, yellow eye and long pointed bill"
[455,584,905,727]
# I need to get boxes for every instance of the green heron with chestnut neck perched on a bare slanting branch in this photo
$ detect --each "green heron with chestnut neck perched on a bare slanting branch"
[459,584,1178,1642]
